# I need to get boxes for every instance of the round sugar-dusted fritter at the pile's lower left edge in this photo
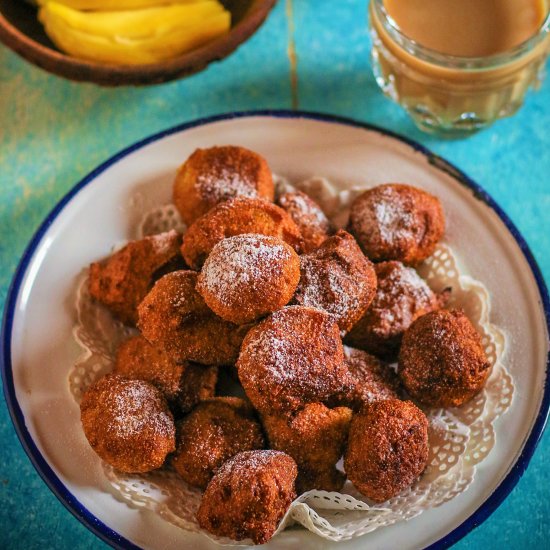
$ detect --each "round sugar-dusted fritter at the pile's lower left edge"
[80,374,176,473]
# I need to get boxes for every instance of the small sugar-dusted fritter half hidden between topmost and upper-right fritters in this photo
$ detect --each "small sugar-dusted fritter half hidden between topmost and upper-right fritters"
[277,191,334,253]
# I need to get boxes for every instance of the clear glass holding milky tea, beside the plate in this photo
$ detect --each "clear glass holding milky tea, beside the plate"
[370,0,550,137]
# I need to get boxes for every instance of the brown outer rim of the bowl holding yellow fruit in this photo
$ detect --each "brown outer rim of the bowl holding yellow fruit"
[0,0,277,86]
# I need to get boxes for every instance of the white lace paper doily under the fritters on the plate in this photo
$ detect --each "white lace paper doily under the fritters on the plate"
[69,178,514,546]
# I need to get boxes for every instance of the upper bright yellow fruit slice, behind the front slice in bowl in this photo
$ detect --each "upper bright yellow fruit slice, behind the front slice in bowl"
[42,0,224,39]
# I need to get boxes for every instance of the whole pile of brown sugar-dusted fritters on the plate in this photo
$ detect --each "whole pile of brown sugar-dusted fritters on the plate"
[81,146,489,543]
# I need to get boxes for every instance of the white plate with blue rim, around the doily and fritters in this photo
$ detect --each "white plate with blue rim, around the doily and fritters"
[2,112,550,550]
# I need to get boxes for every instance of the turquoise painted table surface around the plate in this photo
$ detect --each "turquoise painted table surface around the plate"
[0,0,550,549]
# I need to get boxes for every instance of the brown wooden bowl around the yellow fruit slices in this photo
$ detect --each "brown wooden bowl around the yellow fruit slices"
[0,0,276,86]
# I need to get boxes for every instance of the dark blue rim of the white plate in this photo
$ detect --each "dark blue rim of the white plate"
[0,109,550,550]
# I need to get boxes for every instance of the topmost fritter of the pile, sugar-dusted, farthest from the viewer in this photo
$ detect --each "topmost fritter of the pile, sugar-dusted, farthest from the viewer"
[173,145,275,225]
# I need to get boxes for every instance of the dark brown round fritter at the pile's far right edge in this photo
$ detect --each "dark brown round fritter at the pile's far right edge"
[398,309,491,407]
